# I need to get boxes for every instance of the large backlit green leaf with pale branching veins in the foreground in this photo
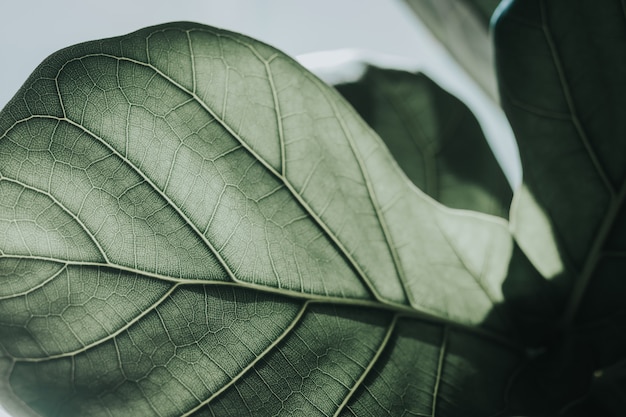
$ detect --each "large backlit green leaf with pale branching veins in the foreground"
[0,23,523,416]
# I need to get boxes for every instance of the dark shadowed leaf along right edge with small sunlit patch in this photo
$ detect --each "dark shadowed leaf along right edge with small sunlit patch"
[495,0,626,415]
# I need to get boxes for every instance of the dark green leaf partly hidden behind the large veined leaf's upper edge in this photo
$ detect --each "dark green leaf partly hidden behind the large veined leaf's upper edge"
[335,66,512,218]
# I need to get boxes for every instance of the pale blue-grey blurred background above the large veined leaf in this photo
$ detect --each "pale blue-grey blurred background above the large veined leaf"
[0,0,519,417]
